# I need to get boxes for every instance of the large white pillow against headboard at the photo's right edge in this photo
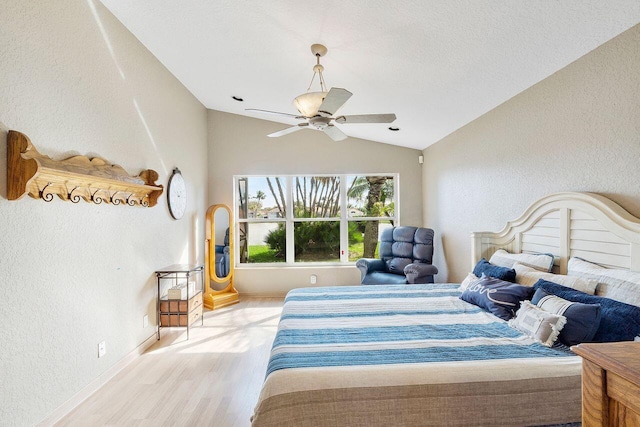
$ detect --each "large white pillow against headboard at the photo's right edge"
[567,258,640,307]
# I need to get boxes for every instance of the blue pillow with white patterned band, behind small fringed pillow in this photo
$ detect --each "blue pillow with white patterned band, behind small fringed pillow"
[531,287,602,346]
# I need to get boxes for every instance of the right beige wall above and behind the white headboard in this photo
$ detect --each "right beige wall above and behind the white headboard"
[423,26,640,281]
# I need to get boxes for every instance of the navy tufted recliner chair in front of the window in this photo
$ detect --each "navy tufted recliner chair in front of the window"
[356,226,438,285]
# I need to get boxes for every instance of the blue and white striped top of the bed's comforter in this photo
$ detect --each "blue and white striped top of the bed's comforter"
[267,284,573,376]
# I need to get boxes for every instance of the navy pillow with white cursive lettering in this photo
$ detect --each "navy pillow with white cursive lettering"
[460,275,533,320]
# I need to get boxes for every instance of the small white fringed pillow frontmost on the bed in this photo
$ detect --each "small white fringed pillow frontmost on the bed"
[509,301,567,347]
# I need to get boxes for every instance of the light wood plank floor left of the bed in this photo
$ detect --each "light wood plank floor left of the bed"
[56,297,283,427]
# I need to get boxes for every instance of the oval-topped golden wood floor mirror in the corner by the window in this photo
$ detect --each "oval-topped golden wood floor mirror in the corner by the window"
[203,204,239,310]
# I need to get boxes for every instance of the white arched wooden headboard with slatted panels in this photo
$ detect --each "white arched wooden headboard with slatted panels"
[471,192,640,274]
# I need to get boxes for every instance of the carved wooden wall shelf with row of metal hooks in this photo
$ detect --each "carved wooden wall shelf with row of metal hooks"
[7,130,163,207]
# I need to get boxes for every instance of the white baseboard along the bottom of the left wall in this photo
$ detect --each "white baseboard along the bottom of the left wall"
[37,332,158,427]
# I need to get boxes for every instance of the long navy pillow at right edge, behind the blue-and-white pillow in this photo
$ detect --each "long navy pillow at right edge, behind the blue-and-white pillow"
[534,279,640,342]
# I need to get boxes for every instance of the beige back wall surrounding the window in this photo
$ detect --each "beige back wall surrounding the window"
[209,111,422,295]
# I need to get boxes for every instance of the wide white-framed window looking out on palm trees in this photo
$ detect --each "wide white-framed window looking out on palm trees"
[234,174,398,265]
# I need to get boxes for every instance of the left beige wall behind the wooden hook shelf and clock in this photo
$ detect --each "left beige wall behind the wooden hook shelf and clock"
[0,0,207,426]
